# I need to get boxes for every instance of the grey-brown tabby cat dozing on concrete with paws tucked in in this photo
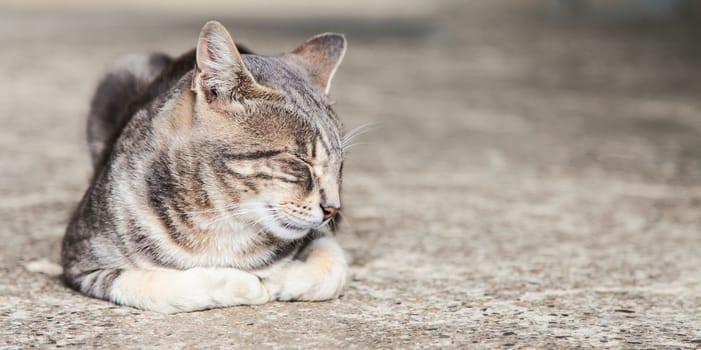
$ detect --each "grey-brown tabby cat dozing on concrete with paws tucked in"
[61,21,347,313]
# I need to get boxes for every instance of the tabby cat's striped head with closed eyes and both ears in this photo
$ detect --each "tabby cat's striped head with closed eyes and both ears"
[191,22,346,239]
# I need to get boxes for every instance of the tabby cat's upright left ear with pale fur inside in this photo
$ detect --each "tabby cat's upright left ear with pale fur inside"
[191,21,274,104]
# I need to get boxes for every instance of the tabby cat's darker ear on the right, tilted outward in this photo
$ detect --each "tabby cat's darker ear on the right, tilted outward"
[292,33,347,94]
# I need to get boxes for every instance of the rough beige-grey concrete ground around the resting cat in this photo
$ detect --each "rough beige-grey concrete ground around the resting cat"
[0,2,701,349]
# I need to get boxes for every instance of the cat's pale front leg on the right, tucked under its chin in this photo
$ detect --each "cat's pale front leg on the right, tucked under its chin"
[263,237,348,301]
